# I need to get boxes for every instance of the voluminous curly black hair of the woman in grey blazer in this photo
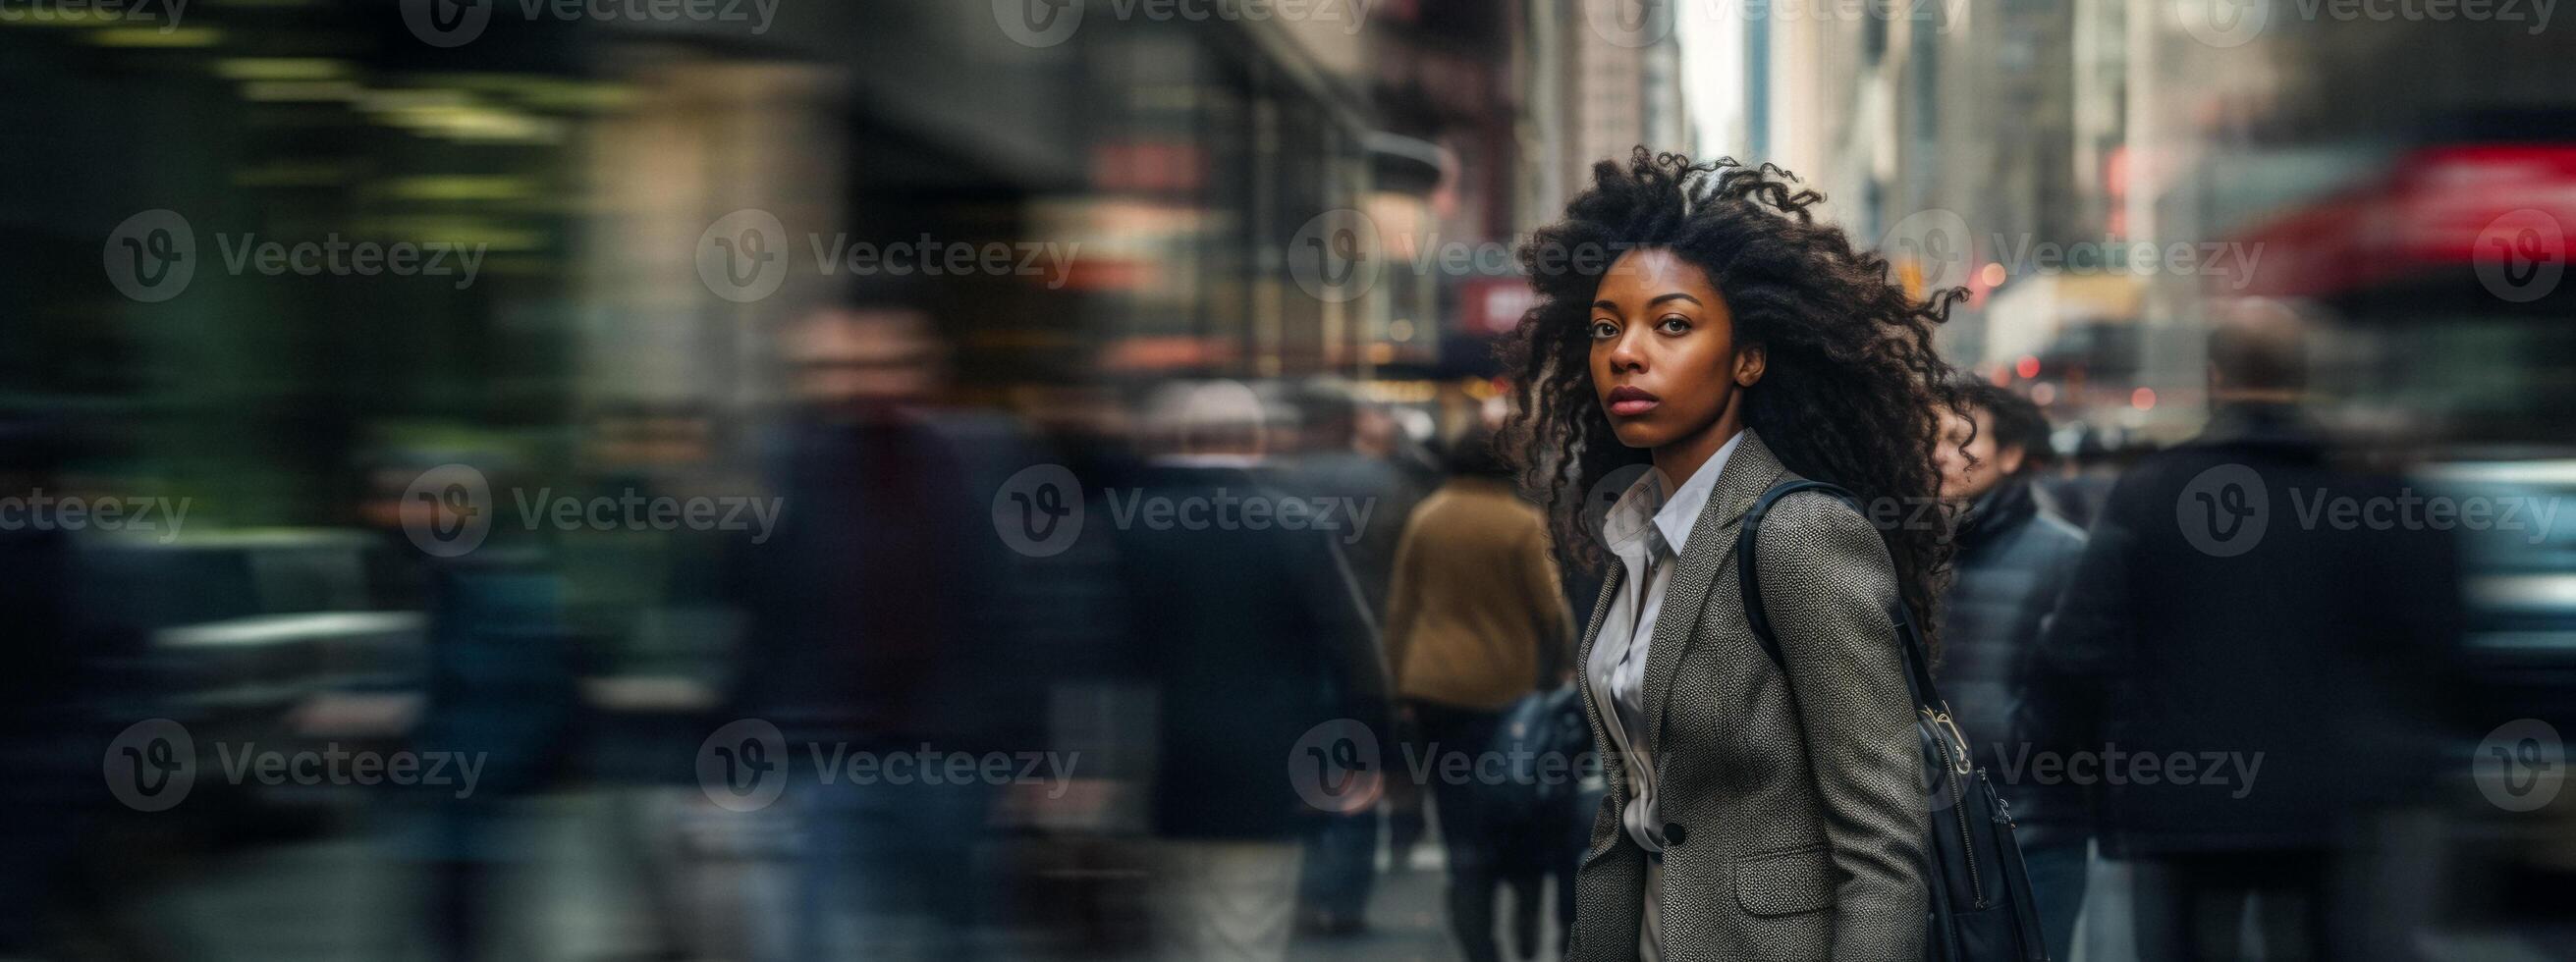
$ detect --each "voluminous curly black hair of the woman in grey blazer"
[1502,146,1965,651]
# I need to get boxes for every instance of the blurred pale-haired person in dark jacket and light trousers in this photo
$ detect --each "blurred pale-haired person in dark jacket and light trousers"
[1113,381,1386,962]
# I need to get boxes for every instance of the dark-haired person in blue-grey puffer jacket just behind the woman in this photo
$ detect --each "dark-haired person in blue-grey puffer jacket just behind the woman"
[1937,381,2092,959]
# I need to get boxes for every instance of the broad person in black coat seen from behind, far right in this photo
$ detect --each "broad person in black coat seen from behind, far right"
[2019,303,2460,959]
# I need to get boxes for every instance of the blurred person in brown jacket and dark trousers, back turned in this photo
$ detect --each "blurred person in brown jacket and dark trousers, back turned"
[1386,432,1574,962]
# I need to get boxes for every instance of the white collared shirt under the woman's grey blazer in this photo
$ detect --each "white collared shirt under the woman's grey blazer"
[1584,430,1744,851]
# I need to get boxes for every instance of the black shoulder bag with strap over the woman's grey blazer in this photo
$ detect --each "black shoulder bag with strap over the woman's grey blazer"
[1736,481,2048,962]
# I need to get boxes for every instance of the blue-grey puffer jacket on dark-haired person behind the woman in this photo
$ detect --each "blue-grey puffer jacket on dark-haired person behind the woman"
[1940,478,2089,843]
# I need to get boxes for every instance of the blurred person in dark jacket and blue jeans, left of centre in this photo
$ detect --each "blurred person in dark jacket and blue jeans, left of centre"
[727,303,1038,962]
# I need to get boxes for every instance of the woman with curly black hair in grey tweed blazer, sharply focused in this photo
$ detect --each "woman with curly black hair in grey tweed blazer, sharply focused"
[1509,149,1957,962]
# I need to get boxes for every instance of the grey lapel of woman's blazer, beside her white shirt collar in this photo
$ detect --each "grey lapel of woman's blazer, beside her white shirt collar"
[1646,427,1787,746]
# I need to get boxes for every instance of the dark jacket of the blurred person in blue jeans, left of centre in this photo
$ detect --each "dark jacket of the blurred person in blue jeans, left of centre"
[727,411,1033,751]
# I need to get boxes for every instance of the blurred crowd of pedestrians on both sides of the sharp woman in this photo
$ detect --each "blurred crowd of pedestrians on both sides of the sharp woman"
[0,294,2571,962]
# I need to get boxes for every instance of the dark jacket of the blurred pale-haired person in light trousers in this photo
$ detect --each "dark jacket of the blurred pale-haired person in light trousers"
[1108,465,1391,841]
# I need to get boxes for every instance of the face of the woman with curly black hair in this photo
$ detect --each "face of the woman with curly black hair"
[1589,247,1762,448]
